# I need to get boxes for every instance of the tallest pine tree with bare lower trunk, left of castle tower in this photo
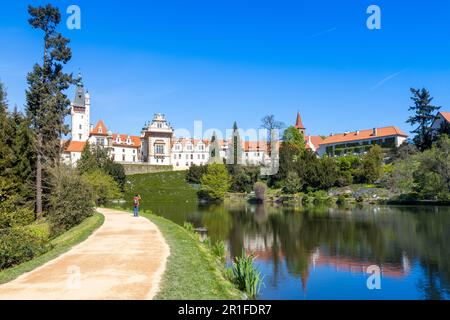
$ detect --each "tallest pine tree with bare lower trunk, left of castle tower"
[26,4,73,218]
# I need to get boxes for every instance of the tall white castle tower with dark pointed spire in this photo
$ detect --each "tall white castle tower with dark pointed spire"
[71,75,91,142]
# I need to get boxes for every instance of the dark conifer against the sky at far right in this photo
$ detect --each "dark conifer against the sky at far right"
[406,88,440,151]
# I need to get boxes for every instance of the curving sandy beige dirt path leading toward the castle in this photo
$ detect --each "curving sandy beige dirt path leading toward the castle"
[0,209,170,300]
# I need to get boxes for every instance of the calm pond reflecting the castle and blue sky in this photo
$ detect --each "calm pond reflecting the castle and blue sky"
[119,201,450,299]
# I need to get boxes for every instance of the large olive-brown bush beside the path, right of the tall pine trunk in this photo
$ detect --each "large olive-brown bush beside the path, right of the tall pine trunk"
[48,166,94,234]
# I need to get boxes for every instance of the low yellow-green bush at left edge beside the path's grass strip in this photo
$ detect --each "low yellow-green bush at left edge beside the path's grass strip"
[0,227,50,270]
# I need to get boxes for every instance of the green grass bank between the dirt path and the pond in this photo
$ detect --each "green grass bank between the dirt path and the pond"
[142,213,243,300]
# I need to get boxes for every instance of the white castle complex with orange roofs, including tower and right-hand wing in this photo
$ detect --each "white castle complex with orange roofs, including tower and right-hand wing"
[62,77,408,170]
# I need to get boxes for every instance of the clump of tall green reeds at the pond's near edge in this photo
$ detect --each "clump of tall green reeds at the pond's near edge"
[232,252,263,298]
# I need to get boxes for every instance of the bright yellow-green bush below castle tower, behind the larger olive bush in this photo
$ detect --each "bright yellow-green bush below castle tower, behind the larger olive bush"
[82,169,120,206]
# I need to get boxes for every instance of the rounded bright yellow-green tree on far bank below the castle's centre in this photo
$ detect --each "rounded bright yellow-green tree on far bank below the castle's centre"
[199,164,230,201]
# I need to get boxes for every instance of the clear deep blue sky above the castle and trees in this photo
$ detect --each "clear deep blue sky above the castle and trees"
[0,0,450,135]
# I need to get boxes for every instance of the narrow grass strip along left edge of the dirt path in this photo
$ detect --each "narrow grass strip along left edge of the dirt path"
[0,213,105,284]
